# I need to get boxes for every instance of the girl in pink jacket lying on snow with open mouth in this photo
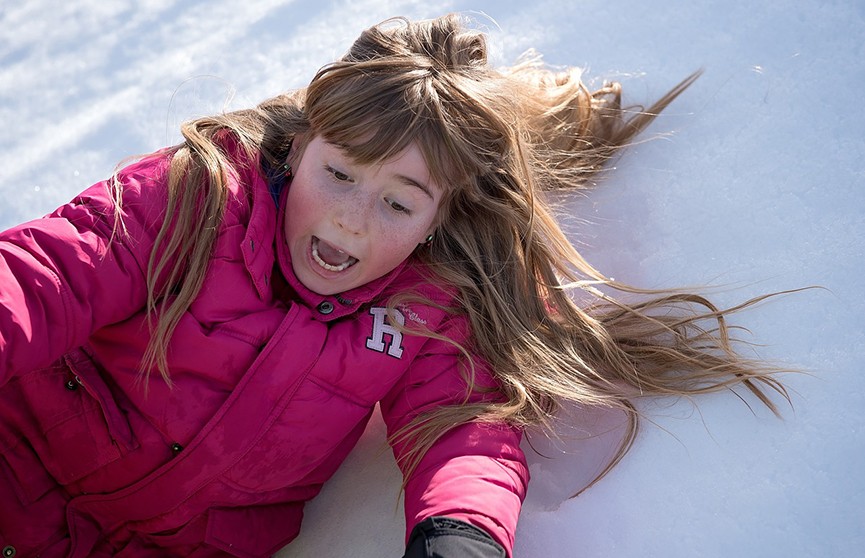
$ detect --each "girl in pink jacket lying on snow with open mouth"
[0,12,783,557]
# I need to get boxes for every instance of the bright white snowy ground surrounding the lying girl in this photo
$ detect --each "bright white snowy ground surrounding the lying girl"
[0,0,865,558]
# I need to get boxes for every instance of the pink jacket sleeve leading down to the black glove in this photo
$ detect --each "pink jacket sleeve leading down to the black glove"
[381,312,529,556]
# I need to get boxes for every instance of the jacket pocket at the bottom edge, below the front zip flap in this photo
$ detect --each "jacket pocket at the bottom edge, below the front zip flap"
[205,502,303,558]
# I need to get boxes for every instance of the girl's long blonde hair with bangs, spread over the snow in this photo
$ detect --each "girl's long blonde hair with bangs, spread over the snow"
[130,15,786,494]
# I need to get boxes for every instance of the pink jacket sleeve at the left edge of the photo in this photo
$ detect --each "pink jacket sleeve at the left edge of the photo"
[0,156,167,385]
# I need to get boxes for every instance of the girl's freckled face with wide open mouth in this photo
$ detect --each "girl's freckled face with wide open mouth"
[285,136,442,295]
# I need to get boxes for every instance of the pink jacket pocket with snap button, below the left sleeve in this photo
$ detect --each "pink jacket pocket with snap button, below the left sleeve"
[0,350,137,485]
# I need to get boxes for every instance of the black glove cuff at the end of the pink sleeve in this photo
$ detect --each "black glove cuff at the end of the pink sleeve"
[403,517,507,558]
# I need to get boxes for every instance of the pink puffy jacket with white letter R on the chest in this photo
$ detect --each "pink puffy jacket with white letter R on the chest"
[0,139,528,557]
